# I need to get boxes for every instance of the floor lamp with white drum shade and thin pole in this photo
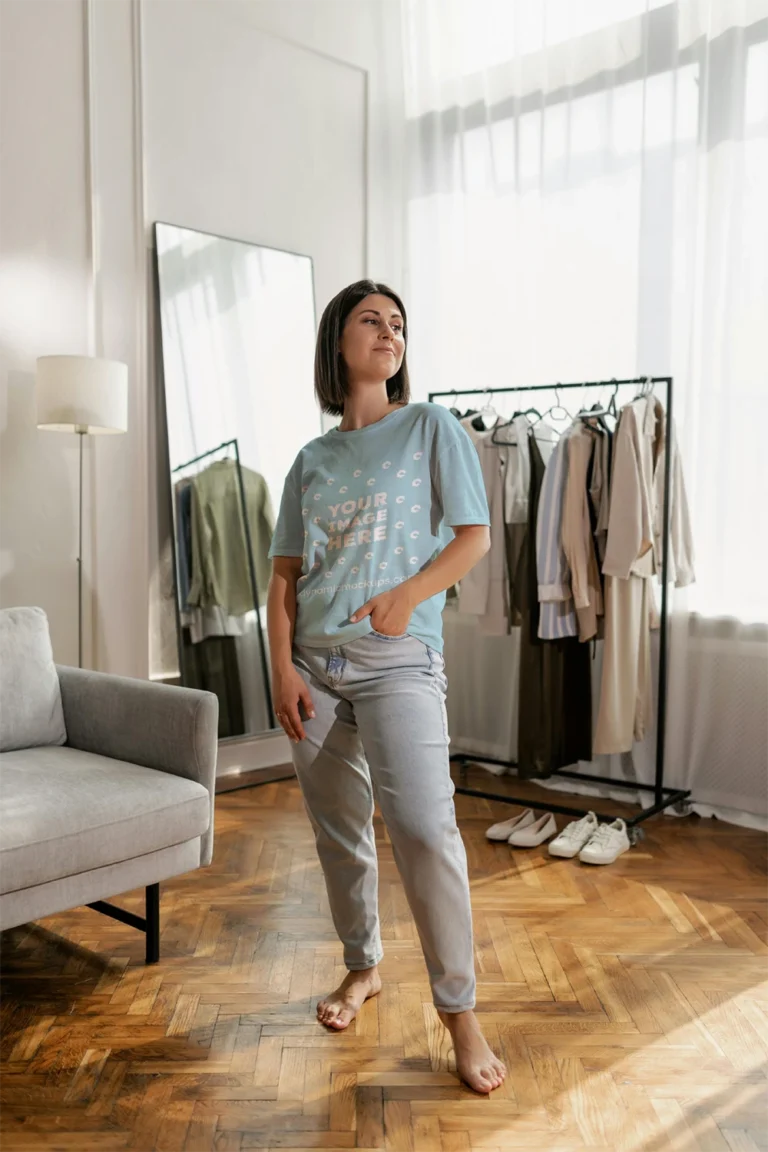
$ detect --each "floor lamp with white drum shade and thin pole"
[37,356,128,668]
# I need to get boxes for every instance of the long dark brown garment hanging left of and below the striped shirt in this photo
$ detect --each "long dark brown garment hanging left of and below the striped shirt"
[510,435,592,780]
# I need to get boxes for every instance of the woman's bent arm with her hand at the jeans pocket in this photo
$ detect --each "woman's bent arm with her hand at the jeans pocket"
[350,524,491,636]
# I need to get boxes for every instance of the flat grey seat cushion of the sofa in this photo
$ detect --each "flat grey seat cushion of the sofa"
[0,748,211,894]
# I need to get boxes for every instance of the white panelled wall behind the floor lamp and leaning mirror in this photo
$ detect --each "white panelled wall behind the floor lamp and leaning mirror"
[0,0,402,676]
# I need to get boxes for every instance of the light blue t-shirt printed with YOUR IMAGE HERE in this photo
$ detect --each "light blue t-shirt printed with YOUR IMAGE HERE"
[269,404,489,652]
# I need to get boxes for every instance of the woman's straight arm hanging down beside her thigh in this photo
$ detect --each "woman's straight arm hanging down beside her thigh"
[267,556,314,742]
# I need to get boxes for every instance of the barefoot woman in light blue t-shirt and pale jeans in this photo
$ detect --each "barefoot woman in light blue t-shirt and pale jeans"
[268,280,505,1092]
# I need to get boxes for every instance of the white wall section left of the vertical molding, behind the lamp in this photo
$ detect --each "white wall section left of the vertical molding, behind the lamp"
[0,0,90,659]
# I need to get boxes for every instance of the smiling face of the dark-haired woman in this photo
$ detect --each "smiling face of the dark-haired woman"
[340,293,405,384]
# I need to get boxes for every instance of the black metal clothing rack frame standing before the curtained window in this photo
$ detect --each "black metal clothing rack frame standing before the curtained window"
[428,376,691,844]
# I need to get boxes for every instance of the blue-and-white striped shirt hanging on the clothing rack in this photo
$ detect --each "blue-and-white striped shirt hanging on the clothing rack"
[534,429,578,641]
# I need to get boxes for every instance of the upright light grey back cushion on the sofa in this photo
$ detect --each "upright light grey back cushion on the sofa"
[0,608,67,752]
